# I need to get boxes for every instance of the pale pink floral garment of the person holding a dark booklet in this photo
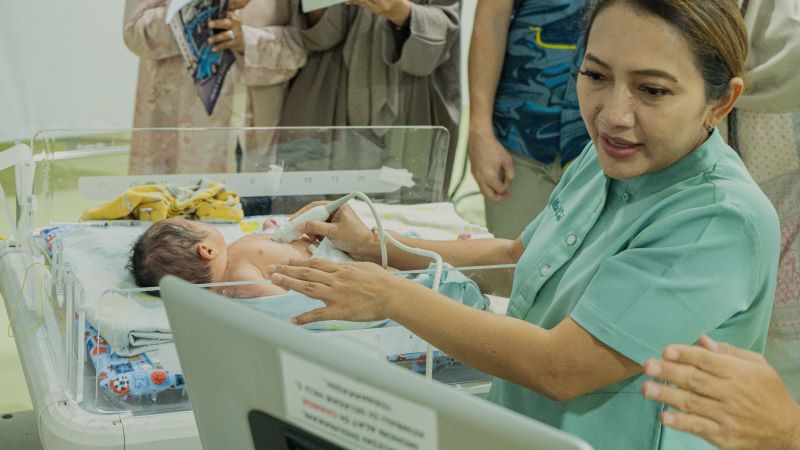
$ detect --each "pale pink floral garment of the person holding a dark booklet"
[123,0,306,174]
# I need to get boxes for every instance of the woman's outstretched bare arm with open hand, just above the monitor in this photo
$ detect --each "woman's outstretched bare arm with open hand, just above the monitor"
[267,241,641,400]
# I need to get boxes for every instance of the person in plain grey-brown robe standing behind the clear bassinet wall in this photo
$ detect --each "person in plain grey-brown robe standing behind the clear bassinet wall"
[281,0,460,189]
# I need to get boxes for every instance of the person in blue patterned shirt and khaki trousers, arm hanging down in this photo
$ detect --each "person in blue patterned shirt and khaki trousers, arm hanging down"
[469,0,589,239]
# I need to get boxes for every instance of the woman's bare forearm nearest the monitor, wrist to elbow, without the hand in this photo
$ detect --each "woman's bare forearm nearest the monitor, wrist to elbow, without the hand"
[386,279,641,401]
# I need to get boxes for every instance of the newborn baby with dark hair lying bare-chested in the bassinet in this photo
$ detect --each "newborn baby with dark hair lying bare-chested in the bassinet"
[128,217,489,316]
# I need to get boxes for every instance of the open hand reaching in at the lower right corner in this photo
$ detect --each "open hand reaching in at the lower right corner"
[642,336,800,449]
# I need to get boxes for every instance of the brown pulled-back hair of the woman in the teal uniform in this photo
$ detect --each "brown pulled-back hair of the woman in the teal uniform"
[583,0,748,102]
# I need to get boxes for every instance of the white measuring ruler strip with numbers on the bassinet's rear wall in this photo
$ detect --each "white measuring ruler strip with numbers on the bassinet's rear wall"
[78,166,414,201]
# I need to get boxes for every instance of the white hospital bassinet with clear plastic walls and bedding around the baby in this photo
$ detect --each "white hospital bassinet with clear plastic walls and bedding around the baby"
[0,127,513,449]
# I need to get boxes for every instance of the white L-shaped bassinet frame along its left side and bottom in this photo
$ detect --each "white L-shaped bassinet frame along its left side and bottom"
[0,242,202,449]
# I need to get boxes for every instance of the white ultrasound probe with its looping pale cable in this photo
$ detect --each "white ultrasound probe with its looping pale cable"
[272,192,443,379]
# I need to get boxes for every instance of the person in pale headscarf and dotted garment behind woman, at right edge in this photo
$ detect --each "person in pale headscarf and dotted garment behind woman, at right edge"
[728,0,800,399]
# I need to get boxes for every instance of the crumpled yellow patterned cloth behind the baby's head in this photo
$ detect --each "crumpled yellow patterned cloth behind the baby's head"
[81,180,244,222]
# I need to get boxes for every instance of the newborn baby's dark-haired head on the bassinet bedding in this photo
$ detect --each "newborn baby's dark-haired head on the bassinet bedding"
[127,217,226,287]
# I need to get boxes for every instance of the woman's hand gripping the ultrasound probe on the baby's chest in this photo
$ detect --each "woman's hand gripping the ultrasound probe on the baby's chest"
[289,201,377,260]
